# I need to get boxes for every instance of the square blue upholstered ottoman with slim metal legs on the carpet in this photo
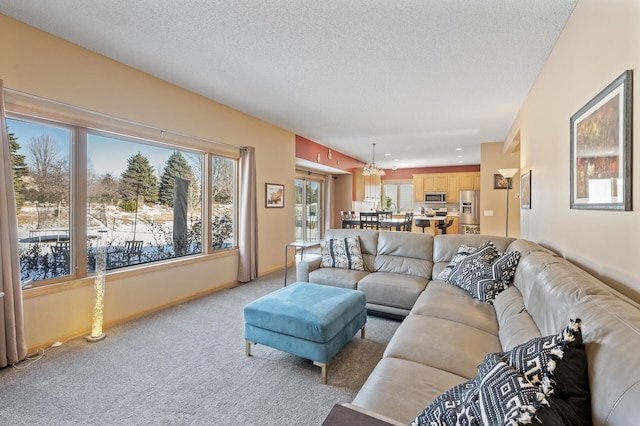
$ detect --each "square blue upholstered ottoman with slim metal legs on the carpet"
[244,282,367,384]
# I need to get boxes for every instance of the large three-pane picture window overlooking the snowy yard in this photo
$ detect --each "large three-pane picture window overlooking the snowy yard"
[6,116,237,286]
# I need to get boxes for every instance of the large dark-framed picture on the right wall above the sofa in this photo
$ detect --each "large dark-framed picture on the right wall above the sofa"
[570,70,633,211]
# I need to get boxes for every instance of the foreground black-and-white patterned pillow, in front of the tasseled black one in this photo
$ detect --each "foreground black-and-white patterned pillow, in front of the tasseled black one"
[411,353,545,426]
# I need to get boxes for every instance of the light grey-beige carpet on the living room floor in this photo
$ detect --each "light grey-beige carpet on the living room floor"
[0,272,399,425]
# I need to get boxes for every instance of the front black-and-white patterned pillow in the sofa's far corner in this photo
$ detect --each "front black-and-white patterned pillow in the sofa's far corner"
[455,251,520,303]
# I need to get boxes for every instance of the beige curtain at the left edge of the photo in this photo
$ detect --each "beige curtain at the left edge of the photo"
[0,80,27,367]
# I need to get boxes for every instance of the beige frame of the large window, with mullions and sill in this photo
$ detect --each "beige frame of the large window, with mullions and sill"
[3,110,240,288]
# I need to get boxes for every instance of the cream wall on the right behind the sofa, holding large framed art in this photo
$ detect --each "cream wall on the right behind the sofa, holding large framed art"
[504,0,640,300]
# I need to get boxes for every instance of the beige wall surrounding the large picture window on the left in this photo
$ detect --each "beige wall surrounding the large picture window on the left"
[0,15,295,348]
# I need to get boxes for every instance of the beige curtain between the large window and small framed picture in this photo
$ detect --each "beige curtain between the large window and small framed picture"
[238,147,258,283]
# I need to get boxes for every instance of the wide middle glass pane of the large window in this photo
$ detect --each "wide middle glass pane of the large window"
[87,133,203,272]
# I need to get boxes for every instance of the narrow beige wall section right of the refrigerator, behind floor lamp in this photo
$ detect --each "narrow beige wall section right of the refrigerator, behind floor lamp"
[480,142,520,238]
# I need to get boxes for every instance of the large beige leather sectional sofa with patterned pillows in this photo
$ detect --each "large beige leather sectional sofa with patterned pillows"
[297,229,640,426]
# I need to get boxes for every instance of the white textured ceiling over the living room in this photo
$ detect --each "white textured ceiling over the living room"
[0,0,578,168]
